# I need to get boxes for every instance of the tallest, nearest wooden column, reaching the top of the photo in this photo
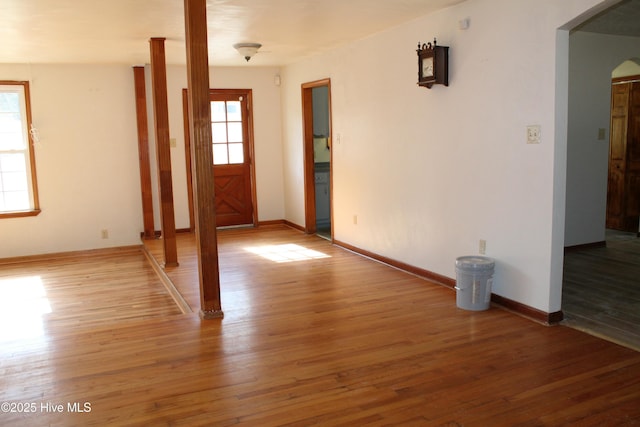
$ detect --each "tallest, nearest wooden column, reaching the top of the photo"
[184,0,224,319]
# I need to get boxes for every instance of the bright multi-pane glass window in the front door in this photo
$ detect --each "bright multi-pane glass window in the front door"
[211,99,244,165]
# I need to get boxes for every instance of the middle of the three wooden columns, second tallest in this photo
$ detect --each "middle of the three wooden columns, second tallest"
[149,37,178,267]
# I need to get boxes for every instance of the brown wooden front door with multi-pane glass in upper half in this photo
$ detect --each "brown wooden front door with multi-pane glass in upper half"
[185,89,256,229]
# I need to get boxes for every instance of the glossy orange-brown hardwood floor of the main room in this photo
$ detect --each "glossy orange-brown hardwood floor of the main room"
[0,226,640,426]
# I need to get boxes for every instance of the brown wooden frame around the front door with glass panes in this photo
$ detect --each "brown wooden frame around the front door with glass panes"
[182,89,258,232]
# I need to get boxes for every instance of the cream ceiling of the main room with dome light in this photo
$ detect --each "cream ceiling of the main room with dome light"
[0,0,464,66]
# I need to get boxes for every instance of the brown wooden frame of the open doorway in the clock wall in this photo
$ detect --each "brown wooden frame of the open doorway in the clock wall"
[302,78,333,236]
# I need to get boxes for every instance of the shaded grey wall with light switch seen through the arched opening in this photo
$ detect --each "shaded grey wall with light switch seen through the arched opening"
[565,31,640,246]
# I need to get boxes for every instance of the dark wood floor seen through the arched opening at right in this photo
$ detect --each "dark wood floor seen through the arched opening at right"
[562,233,640,351]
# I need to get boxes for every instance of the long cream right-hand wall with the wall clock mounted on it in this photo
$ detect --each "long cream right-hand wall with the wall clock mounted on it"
[282,0,598,312]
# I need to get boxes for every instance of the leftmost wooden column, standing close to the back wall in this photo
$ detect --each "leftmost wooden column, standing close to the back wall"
[133,67,156,239]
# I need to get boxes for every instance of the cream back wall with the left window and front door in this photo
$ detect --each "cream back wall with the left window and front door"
[0,64,284,258]
